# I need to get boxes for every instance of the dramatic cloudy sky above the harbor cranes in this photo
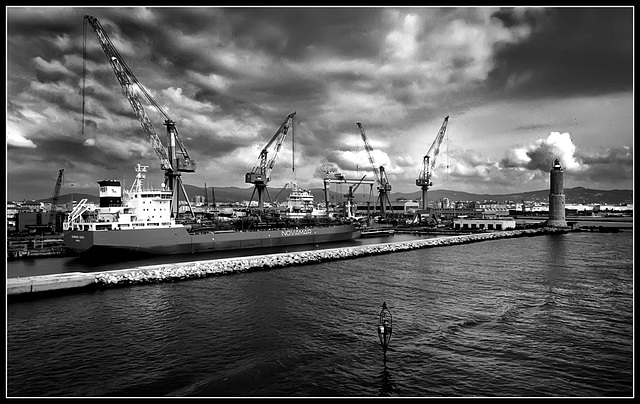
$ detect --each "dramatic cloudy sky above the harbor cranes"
[6,7,634,200]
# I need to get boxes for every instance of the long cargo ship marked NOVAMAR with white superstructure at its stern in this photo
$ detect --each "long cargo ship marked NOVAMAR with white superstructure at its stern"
[63,164,360,256]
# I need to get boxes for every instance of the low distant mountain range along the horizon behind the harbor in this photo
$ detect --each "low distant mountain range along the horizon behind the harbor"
[39,185,633,205]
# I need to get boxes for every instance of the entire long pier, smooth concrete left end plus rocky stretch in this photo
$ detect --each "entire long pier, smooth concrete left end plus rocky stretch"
[7,227,574,300]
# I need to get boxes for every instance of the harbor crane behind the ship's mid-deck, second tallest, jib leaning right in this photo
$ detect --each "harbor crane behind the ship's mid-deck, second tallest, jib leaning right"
[244,111,296,209]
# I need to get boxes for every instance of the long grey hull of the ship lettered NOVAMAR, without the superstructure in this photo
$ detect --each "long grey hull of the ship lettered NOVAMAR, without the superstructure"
[64,225,359,255]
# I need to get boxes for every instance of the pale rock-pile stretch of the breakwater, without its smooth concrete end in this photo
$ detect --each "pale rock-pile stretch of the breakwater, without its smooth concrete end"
[95,227,569,287]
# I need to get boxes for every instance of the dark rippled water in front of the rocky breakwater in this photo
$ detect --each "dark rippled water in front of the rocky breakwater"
[7,232,633,397]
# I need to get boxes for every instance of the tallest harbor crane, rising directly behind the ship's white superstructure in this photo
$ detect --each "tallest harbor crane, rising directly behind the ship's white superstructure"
[83,15,196,218]
